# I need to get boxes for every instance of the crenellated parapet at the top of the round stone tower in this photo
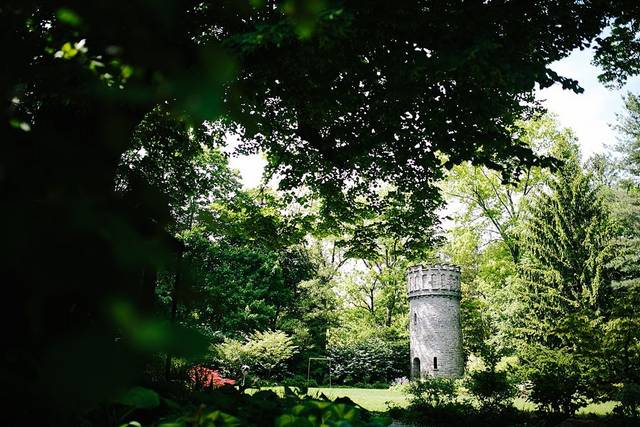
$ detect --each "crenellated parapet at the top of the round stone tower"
[407,264,460,299]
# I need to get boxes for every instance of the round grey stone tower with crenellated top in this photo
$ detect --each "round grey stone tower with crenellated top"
[407,264,464,378]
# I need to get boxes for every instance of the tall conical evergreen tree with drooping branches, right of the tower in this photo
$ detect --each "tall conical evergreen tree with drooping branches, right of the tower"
[518,143,613,413]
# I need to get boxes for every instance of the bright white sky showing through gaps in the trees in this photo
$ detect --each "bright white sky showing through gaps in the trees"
[229,50,640,188]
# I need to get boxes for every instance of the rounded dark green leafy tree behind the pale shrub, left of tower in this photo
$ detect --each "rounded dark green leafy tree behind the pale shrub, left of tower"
[171,191,316,336]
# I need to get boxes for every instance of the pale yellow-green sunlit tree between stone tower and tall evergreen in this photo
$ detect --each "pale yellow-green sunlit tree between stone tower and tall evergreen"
[441,115,575,357]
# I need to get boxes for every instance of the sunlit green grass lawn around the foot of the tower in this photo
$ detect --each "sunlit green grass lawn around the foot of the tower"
[255,387,615,415]
